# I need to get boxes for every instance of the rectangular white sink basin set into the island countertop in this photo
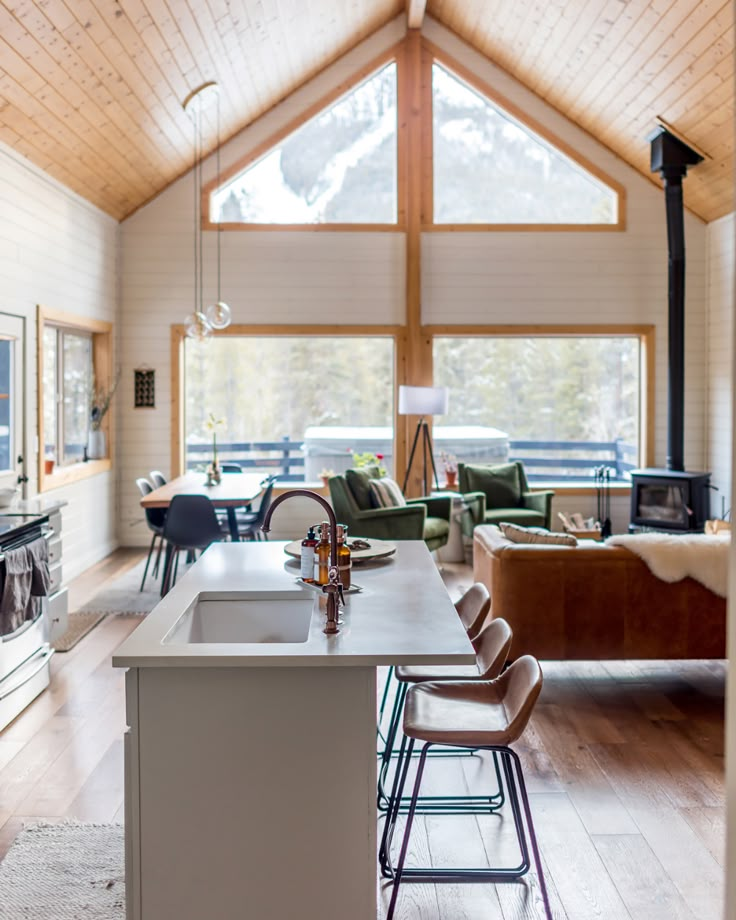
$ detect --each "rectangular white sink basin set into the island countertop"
[162,590,314,645]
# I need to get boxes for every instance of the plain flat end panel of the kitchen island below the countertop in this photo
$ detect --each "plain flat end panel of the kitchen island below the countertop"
[136,667,376,920]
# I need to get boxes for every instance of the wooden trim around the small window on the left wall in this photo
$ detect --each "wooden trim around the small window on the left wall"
[36,304,115,493]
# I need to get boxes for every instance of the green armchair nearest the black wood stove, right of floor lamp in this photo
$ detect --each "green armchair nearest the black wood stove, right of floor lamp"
[457,460,555,530]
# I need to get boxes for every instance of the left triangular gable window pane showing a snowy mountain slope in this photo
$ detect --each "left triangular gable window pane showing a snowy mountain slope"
[210,63,397,225]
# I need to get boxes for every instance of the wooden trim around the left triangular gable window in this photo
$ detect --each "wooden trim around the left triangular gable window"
[200,41,407,233]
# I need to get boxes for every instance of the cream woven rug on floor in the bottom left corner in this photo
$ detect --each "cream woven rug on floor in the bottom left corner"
[0,824,125,920]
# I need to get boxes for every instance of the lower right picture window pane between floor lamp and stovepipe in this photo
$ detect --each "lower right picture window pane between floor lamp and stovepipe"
[433,334,645,484]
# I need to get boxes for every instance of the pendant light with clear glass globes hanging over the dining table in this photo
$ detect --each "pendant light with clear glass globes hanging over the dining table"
[182,80,230,342]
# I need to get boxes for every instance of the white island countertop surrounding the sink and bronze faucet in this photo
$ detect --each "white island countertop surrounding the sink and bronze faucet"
[113,540,475,668]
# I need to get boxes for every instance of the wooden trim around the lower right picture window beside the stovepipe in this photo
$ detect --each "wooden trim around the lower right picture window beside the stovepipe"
[423,324,656,495]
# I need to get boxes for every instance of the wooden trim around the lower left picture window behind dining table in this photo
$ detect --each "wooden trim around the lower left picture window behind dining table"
[171,323,406,478]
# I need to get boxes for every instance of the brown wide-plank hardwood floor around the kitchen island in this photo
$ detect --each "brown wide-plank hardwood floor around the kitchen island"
[0,550,726,920]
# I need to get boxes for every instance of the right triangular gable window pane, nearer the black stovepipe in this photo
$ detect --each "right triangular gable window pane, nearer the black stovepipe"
[432,63,618,225]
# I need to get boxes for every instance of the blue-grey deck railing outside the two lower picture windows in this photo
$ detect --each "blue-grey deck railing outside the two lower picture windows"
[187,436,637,482]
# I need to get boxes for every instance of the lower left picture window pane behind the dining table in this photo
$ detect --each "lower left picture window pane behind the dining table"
[183,331,395,482]
